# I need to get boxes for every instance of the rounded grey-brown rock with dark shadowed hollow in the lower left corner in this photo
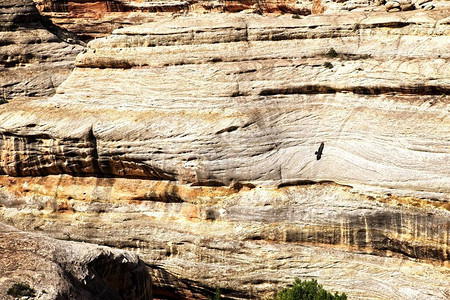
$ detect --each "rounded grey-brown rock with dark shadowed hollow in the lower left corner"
[0,223,152,299]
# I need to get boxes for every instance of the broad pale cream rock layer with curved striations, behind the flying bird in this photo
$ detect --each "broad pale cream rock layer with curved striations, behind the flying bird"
[0,12,450,200]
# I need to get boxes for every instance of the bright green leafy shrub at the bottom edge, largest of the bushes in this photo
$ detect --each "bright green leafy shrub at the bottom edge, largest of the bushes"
[273,279,347,300]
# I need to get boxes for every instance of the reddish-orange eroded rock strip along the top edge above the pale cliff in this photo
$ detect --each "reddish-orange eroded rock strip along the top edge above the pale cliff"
[34,0,450,41]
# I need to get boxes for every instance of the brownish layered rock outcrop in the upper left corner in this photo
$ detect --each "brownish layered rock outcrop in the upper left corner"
[0,0,82,102]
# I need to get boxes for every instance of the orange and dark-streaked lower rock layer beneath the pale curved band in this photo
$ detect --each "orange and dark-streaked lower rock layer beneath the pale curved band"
[0,176,450,299]
